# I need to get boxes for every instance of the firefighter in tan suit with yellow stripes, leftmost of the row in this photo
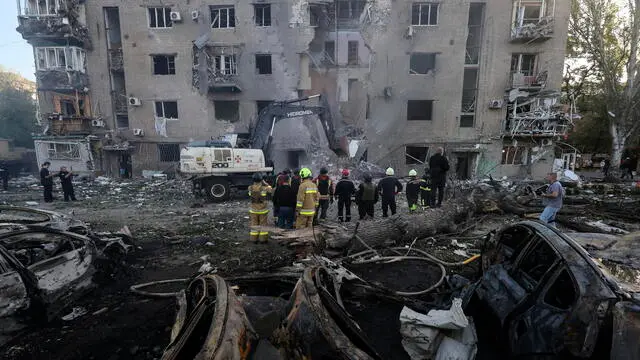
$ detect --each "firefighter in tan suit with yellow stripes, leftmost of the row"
[249,173,272,243]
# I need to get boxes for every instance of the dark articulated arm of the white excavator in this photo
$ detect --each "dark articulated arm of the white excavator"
[249,95,339,156]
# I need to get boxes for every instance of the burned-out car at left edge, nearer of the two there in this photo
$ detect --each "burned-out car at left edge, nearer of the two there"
[0,224,127,345]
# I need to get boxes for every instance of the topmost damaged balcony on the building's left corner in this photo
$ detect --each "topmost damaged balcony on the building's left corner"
[16,15,91,49]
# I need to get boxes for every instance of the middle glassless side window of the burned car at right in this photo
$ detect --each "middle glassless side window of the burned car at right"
[516,238,558,291]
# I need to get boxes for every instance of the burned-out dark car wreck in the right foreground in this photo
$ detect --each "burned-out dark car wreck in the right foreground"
[465,221,640,359]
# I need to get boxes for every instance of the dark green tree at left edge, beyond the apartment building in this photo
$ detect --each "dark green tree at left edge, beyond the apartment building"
[0,68,36,148]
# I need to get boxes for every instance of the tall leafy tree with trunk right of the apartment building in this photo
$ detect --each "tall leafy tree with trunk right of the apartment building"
[568,0,640,165]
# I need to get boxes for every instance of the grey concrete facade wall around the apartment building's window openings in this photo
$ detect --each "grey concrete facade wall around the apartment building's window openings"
[20,0,569,177]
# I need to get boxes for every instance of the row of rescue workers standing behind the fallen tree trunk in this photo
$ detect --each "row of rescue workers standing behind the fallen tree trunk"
[244,148,449,242]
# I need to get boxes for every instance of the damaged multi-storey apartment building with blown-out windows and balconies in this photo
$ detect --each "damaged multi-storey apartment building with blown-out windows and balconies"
[18,0,569,178]
